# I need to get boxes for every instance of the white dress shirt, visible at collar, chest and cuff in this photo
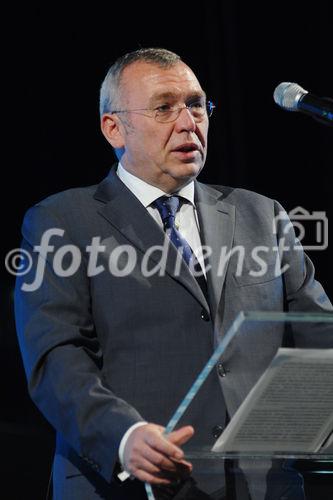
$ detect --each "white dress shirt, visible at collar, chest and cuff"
[117,163,205,472]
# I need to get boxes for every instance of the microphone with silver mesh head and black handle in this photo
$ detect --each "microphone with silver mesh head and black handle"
[273,82,333,126]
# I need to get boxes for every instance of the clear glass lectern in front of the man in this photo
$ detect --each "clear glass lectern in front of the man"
[146,312,333,500]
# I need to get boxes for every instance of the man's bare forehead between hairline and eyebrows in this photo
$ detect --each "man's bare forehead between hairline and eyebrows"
[121,61,203,98]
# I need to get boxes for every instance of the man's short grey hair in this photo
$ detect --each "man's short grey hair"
[99,48,181,116]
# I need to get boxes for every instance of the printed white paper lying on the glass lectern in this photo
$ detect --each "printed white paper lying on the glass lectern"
[212,348,333,453]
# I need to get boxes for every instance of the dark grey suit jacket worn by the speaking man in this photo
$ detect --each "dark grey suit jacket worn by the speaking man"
[15,169,332,500]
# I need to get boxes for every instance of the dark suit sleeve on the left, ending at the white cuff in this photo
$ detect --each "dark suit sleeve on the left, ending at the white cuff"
[15,205,143,481]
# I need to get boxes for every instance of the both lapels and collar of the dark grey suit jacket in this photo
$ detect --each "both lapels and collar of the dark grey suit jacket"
[94,168,234,317]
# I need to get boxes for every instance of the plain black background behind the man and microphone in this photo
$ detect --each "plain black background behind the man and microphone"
[0,1,333,500]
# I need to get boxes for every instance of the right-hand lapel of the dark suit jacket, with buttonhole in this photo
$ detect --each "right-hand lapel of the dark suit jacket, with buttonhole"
[196,182,235,317]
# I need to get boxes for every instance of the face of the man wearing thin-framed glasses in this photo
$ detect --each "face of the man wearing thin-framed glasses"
[110,62,208,192]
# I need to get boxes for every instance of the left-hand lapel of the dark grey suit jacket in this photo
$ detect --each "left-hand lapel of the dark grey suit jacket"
[94,168,209,312]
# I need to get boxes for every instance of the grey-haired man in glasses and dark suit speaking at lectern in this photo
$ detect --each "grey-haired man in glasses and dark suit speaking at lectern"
[15,49,332,500]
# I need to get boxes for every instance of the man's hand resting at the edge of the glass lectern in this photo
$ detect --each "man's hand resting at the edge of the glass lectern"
[124,424,194,484]
